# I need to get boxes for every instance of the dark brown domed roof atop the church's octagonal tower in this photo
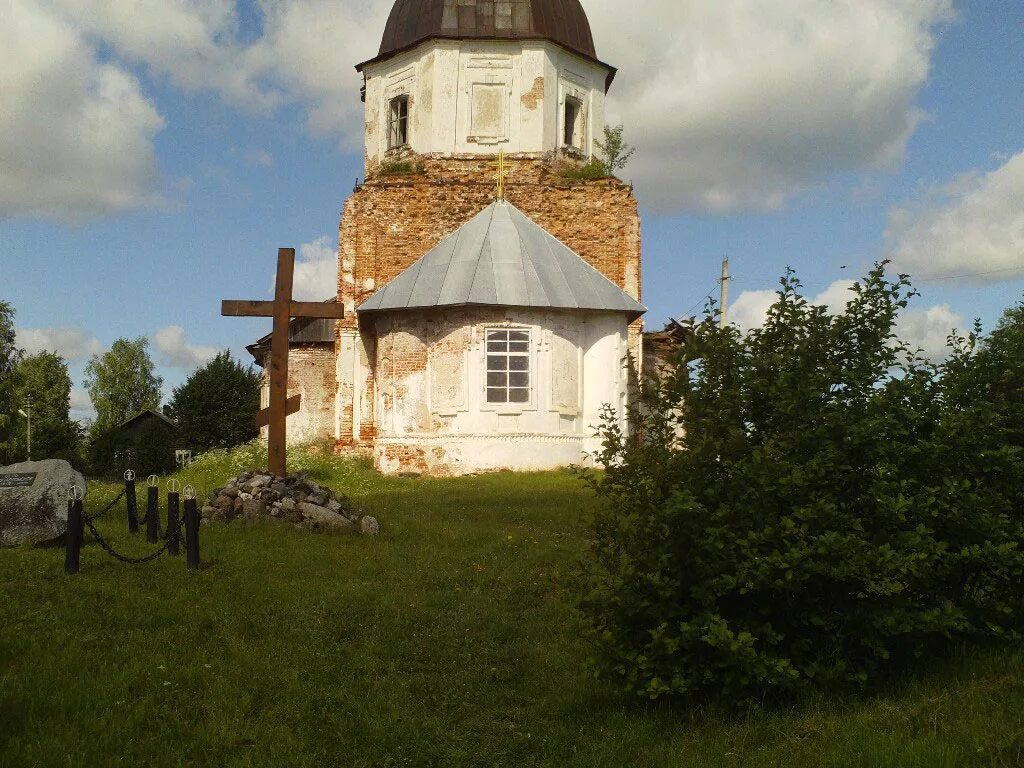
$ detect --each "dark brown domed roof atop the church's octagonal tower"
[368,0,597,63]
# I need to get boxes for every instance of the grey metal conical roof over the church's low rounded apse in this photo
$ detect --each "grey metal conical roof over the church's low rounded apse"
[358,201,647,319]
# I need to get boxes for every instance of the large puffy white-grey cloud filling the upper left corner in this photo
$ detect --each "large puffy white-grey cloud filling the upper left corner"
[0,0,164,221]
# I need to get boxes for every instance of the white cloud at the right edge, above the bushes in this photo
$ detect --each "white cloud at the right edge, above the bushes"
[886,153,1024,283]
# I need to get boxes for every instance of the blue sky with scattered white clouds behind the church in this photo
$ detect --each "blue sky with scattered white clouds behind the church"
[0,0,1024,421]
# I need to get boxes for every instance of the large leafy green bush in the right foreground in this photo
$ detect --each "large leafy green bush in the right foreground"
[583,265,1024,701]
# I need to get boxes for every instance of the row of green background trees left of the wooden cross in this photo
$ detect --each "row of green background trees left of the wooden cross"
[0,300,262,474]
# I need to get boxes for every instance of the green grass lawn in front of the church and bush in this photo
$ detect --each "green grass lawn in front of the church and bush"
[0,454,1024,768]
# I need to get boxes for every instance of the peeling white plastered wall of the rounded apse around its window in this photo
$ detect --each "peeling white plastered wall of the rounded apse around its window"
[364,308,628,474]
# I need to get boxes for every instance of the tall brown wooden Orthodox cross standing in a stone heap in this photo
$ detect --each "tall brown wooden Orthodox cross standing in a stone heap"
[220,248,345,477]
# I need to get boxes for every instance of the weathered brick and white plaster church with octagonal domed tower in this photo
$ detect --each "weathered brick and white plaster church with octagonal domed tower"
[251,0,645,475]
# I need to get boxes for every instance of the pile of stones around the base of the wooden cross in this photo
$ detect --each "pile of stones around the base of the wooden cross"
[203,472,380,536]
